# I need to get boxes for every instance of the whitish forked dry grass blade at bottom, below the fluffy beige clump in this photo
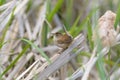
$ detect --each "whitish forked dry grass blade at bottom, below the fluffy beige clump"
[66,47,109,80]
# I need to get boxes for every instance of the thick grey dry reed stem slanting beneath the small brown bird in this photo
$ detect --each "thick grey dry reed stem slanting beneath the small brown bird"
[38,34,85,80]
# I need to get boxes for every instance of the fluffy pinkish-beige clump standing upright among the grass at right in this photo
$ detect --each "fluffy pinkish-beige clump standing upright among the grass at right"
[93,11,117,47]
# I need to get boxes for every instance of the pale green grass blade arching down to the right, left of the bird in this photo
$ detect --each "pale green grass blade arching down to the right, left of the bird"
[21,39,51,63]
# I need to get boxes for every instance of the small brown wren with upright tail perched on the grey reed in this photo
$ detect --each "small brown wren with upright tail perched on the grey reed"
[53,27,73,49]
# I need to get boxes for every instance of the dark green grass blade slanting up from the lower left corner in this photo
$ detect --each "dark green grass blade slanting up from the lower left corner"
[0,45,30,79]
